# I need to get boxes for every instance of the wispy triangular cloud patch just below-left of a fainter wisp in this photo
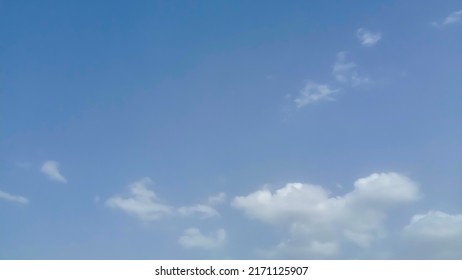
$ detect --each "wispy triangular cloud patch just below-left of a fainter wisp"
[294,81,338,108]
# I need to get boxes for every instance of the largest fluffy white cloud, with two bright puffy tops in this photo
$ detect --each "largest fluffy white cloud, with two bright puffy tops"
[232,173,419,258]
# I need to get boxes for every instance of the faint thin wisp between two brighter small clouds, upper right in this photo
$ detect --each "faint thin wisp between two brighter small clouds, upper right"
[332,52,372,87]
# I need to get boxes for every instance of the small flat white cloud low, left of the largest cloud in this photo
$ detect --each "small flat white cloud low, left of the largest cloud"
[178,228,226,250]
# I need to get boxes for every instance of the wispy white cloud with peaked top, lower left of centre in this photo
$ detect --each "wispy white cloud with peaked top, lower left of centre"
[106,177,172,221]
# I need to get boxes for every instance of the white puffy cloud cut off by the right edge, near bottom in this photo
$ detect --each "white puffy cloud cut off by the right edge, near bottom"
[403,211,462,259]
